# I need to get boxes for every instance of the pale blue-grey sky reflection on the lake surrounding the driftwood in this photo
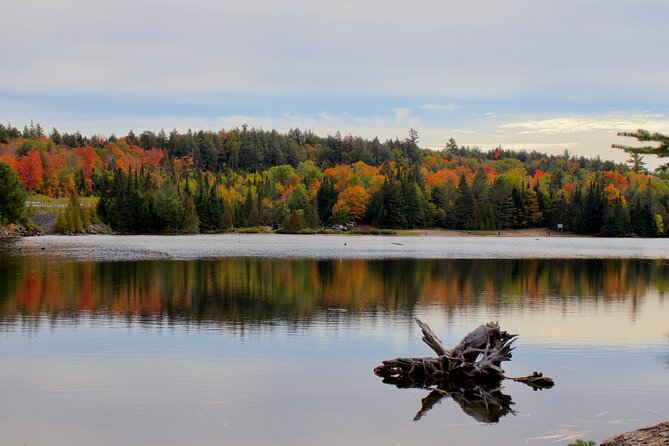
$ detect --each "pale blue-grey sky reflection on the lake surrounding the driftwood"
[0,296,669,445]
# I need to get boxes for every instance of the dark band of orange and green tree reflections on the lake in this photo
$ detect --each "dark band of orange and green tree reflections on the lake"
[0,255,669,324]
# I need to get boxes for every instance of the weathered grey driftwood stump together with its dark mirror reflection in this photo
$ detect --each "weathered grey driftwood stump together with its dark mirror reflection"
[374,318,554,423]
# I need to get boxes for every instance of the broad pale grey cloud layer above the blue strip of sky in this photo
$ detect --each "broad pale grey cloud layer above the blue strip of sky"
[0,0,669,102]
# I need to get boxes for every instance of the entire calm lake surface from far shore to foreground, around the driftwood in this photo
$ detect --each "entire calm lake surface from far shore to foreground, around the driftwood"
[0,235,669,445]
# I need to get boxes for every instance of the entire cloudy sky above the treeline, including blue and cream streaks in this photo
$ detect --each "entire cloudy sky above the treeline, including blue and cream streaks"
[0,0,669,167]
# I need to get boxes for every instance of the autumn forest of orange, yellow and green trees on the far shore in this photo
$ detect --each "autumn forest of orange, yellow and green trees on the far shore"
[0,123,669,237]
